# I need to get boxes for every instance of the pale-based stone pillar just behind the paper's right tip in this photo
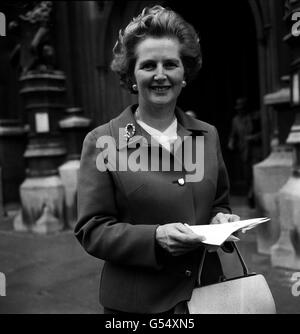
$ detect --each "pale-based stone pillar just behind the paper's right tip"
[253,82,294,255]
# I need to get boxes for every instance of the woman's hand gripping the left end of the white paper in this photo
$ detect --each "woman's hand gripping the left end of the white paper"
[156,223,205,256]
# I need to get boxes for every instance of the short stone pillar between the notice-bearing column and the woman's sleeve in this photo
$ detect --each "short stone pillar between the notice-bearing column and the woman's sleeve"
[59,108,91,228]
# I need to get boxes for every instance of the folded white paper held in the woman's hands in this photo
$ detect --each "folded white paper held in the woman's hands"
[185,218,270,246]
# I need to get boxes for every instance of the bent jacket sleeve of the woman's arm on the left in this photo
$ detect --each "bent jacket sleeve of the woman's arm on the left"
[74,133,161,269]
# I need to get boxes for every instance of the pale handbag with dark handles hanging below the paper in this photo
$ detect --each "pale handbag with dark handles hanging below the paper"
[187,242,276,314]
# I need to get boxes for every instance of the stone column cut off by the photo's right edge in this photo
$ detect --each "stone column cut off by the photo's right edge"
[271,0,300,270]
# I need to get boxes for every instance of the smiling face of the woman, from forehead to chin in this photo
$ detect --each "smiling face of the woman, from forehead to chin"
[134,37,184,106]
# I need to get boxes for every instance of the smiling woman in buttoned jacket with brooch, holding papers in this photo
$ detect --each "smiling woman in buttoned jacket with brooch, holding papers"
[75,6,238,313]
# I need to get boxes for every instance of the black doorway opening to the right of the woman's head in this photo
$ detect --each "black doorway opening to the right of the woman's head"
[164,0,259,194]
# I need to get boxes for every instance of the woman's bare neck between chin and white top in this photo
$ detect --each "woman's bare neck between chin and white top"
[136,105,175,131]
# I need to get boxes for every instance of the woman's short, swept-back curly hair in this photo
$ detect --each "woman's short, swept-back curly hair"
[111,5,202,93]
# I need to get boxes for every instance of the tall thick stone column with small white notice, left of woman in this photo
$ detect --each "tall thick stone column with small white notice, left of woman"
[10,1,66,233]
